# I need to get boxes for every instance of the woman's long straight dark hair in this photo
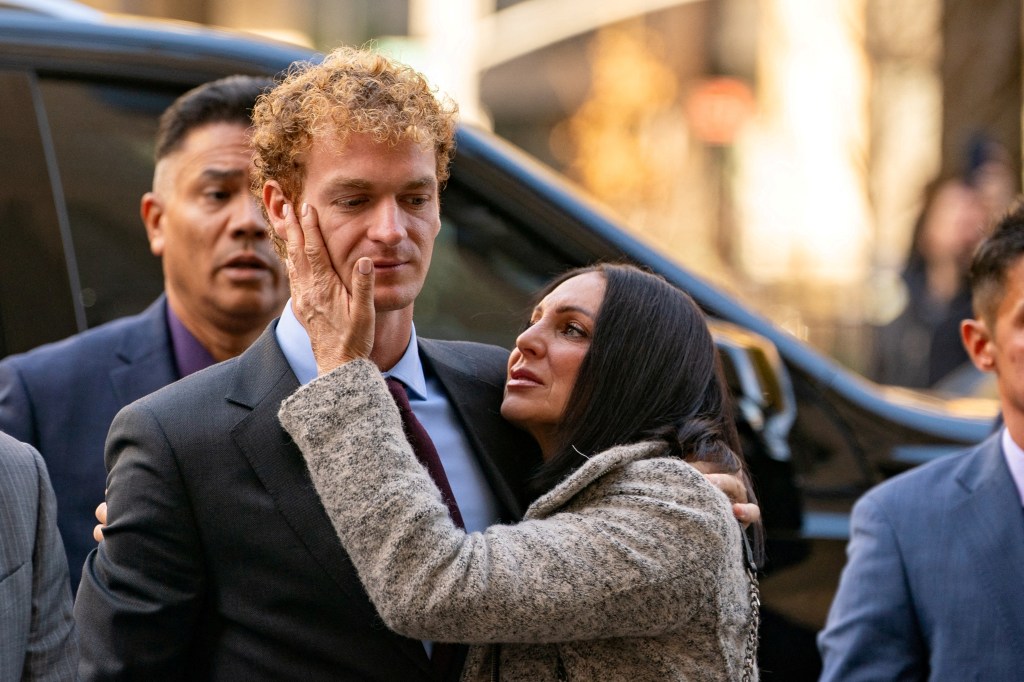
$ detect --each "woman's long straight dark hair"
[534,263,761,549]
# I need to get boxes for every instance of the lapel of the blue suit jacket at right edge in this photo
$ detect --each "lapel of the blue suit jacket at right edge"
[951,433,1024,642]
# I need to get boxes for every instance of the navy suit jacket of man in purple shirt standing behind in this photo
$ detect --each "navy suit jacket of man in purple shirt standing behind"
[0,297,177,589]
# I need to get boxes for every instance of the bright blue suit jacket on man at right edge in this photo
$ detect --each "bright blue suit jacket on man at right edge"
[818,433,1024,682]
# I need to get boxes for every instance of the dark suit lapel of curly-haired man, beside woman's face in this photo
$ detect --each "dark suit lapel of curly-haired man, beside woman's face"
[419,338,541,520]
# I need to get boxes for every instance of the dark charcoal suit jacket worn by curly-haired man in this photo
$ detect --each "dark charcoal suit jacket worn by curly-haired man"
[75,325,539,682]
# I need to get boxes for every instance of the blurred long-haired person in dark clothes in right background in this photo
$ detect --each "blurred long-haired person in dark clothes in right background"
[871,177,988,388]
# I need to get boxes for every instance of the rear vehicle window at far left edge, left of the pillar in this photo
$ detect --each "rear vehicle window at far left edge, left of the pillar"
[0,71,78,357]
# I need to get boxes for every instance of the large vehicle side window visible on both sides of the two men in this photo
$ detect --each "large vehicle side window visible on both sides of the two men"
[12,78,572,347]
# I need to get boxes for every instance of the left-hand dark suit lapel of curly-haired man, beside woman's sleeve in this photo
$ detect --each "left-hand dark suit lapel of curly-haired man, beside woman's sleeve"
[226,324,429,675]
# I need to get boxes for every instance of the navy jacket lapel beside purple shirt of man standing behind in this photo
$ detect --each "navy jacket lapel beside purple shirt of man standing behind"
[110,296,178,404]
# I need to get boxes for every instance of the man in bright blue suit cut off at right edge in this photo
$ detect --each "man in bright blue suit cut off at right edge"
[818,200,1024,682]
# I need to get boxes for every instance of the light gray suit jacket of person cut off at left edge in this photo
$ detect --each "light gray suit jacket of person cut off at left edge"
[0,432,78,682]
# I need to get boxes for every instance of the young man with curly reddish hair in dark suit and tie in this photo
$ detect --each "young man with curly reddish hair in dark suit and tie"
[75,43,539,681]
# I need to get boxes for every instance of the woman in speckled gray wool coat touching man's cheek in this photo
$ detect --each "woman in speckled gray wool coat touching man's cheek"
[279,253,758,682]
